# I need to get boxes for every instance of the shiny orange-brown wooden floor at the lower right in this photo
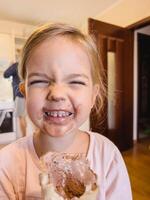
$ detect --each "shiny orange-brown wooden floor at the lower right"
[123,139,150,200]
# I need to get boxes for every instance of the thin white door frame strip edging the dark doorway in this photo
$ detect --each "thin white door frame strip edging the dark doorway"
[133,25,150,140]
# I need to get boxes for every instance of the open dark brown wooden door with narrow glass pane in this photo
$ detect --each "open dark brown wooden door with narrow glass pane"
[88,19,133,150]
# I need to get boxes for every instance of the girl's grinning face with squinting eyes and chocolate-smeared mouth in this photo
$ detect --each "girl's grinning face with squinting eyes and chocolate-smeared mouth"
[26,36,98,137]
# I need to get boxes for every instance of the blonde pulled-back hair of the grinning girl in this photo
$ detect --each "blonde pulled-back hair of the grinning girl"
[19,23,106,127]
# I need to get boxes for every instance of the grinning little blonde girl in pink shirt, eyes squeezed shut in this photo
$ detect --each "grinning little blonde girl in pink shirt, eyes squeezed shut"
[0,24,132,200]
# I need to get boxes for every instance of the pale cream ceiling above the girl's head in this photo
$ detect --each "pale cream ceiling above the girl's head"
[0,0,120,26]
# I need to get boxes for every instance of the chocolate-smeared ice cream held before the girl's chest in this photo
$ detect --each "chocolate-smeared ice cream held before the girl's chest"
[40,153,98,200]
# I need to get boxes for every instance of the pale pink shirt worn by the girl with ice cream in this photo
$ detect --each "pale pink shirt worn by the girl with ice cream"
[0,132,132,200]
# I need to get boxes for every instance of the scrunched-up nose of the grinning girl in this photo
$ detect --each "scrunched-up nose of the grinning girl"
[47,85,65,102]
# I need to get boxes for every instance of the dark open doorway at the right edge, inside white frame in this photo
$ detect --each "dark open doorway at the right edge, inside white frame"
[137,32,150,140]
